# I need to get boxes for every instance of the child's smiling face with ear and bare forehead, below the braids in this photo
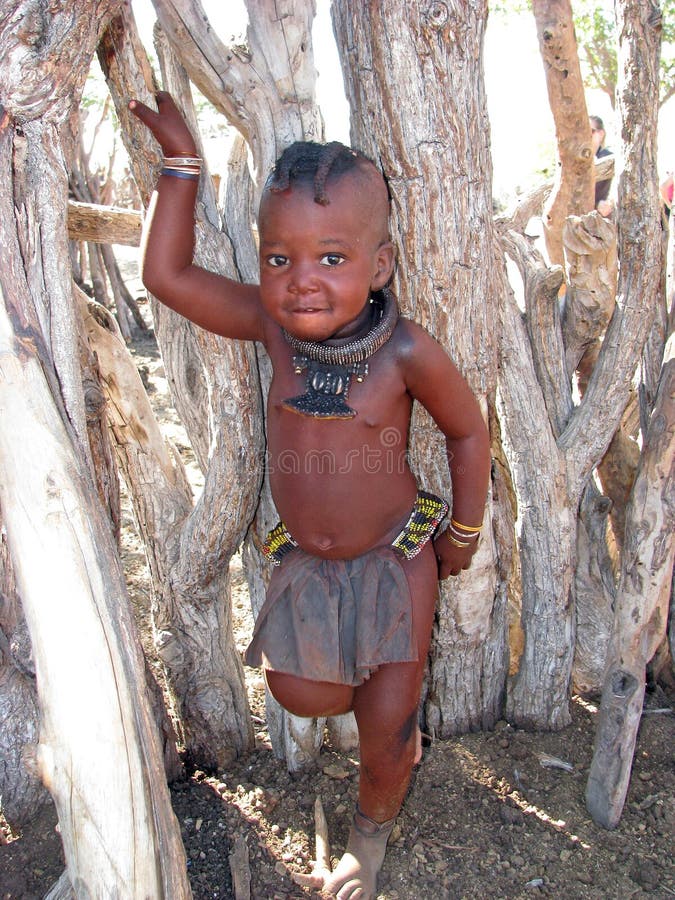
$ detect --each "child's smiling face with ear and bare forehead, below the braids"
[259,174,393,341]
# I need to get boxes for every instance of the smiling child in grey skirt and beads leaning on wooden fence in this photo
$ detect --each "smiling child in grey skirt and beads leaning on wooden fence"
[129,93,490,898]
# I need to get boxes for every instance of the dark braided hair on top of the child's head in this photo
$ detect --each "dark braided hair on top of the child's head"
[266,141,372,206]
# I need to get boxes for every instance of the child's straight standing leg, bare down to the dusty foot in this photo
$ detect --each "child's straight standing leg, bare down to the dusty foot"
[323,544,438,900]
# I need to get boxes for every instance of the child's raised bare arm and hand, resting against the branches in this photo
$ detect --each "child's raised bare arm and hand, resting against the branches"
[129,91,263,340]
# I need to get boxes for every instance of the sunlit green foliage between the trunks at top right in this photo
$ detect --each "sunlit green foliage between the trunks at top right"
[489,0,675,106]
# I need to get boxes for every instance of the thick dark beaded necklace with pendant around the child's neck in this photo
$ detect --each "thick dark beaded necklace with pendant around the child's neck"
[283,288,398,419]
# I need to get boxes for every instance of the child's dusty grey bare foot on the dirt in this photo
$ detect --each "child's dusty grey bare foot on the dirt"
[295,809,396,900]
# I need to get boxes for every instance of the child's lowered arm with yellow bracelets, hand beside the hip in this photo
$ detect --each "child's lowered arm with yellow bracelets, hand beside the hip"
[403,322,490,578]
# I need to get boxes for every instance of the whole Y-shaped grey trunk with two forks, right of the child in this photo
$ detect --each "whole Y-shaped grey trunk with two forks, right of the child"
[500,4,660,728]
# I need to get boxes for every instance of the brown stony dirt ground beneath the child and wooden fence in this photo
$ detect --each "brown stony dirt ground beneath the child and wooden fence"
[0,318,675,900]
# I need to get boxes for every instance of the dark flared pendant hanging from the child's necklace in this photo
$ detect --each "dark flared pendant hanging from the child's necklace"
[282,356,368,419]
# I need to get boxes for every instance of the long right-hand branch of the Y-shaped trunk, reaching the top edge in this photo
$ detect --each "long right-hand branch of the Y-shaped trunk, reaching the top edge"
[559,0,661,497]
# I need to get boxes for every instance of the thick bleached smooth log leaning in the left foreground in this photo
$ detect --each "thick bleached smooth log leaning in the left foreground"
[0,290,190,898]
